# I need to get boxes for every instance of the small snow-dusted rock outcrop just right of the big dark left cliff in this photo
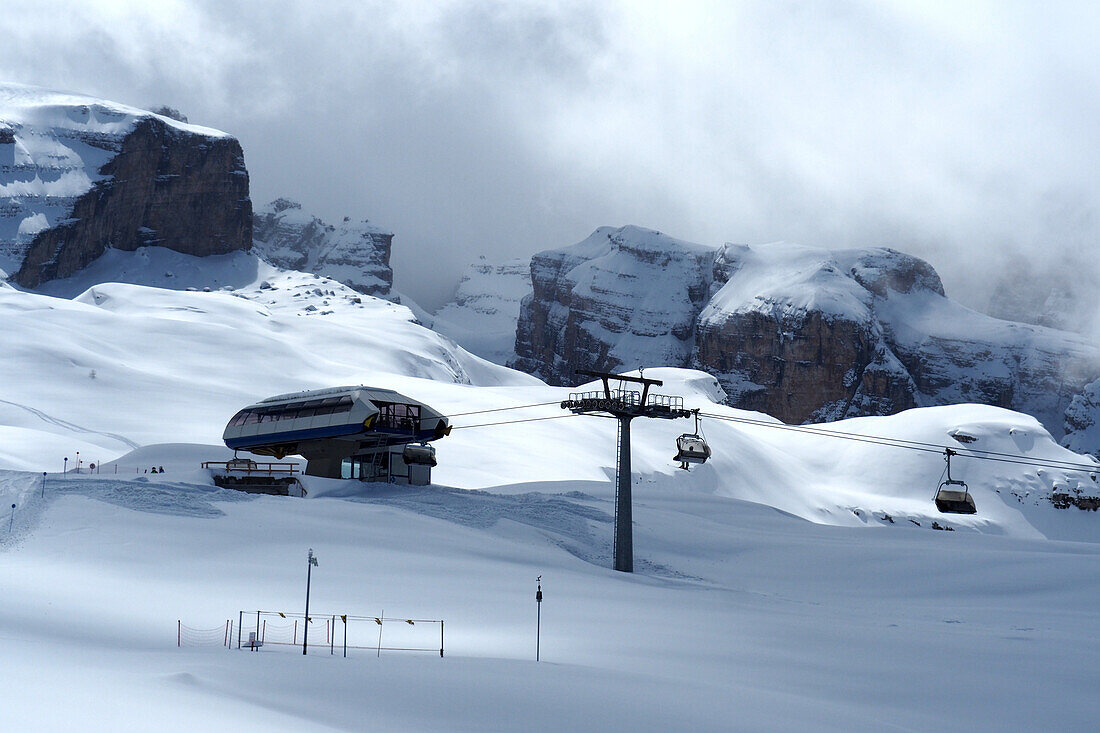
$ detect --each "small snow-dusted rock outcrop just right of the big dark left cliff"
[253,198,394,297]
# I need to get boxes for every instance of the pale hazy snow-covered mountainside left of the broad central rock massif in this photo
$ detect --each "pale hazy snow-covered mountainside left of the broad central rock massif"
[430,256,531,364]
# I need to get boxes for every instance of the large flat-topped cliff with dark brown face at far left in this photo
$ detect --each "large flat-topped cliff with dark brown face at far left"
[0,85,252,287]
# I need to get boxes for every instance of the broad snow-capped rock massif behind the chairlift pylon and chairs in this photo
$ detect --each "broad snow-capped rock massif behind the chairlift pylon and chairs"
[513,227,1100,450]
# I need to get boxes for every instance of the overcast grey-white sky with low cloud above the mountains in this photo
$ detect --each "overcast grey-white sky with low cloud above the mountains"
[0,0,1100,307]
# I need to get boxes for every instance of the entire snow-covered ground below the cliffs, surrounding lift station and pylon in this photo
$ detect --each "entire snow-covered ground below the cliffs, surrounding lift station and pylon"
[0,259,1100,731]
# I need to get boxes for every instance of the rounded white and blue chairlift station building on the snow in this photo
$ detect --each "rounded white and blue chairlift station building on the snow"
[222,386,451,485]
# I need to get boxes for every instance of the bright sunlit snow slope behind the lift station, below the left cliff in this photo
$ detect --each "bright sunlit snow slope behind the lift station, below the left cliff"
[0,267,534,467]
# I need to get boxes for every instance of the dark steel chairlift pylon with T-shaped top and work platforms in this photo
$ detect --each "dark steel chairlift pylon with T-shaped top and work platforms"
[561,371,693,572]
